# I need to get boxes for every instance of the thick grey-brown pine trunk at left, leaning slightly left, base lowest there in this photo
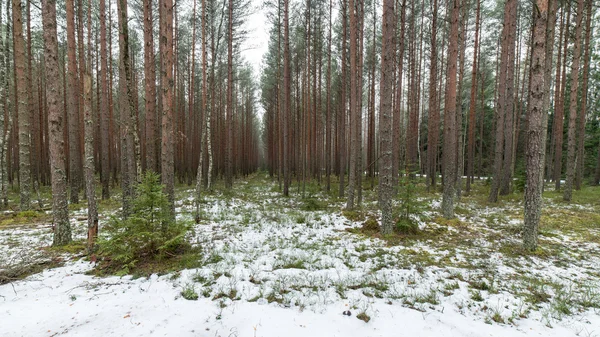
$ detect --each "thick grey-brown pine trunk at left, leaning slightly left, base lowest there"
[42,0,71,246]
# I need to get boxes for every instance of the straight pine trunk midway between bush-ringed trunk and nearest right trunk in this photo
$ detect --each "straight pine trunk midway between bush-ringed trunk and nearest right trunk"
[442,0,461,219]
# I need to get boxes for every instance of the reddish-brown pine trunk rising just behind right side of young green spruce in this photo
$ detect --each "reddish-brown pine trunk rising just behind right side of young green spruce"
[160,0,175,218]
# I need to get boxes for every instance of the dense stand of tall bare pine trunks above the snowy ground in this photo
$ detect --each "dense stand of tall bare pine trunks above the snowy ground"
[0,0,600,248]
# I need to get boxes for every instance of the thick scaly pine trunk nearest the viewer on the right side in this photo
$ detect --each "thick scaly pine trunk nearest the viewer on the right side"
[523,0,548,251]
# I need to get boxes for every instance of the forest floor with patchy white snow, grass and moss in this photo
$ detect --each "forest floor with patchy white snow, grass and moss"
[0,173,600,337]
